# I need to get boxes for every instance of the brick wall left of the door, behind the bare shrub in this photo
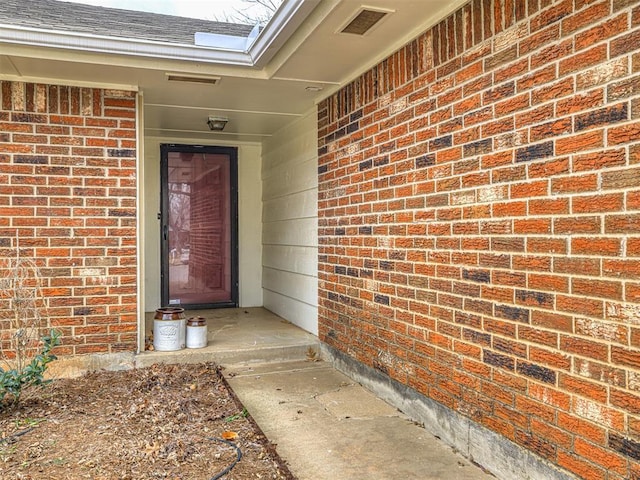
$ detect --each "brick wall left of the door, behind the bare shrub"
[0,81,137,355]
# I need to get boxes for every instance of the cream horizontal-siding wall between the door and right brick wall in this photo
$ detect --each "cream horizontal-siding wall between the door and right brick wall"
[260,108,318,335]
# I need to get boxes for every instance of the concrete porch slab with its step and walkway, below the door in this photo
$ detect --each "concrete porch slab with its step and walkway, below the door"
[136,308,494,480]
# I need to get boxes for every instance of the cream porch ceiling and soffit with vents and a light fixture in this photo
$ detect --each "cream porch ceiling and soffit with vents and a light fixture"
[0,0,465,142]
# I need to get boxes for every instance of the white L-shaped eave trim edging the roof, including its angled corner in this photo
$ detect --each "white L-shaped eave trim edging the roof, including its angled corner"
[0,0,320,67]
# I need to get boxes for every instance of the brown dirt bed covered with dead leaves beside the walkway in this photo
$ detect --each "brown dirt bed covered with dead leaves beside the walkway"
[0,363,295,480]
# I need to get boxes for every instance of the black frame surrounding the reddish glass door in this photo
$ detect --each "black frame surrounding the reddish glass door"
[160,143,239,310]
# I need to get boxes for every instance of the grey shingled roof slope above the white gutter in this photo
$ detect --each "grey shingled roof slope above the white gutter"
[0,0,253,45]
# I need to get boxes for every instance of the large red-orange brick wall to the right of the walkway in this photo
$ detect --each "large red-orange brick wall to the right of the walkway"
[318,0,640,480]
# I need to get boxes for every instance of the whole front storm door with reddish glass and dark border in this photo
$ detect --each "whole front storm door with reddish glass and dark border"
[160,145,238,308]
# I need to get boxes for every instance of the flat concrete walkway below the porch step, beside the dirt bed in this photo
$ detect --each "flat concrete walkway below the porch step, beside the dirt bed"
[225,361,494,480]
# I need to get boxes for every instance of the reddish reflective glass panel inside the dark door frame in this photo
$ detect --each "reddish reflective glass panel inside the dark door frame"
[166,151,233,306]
